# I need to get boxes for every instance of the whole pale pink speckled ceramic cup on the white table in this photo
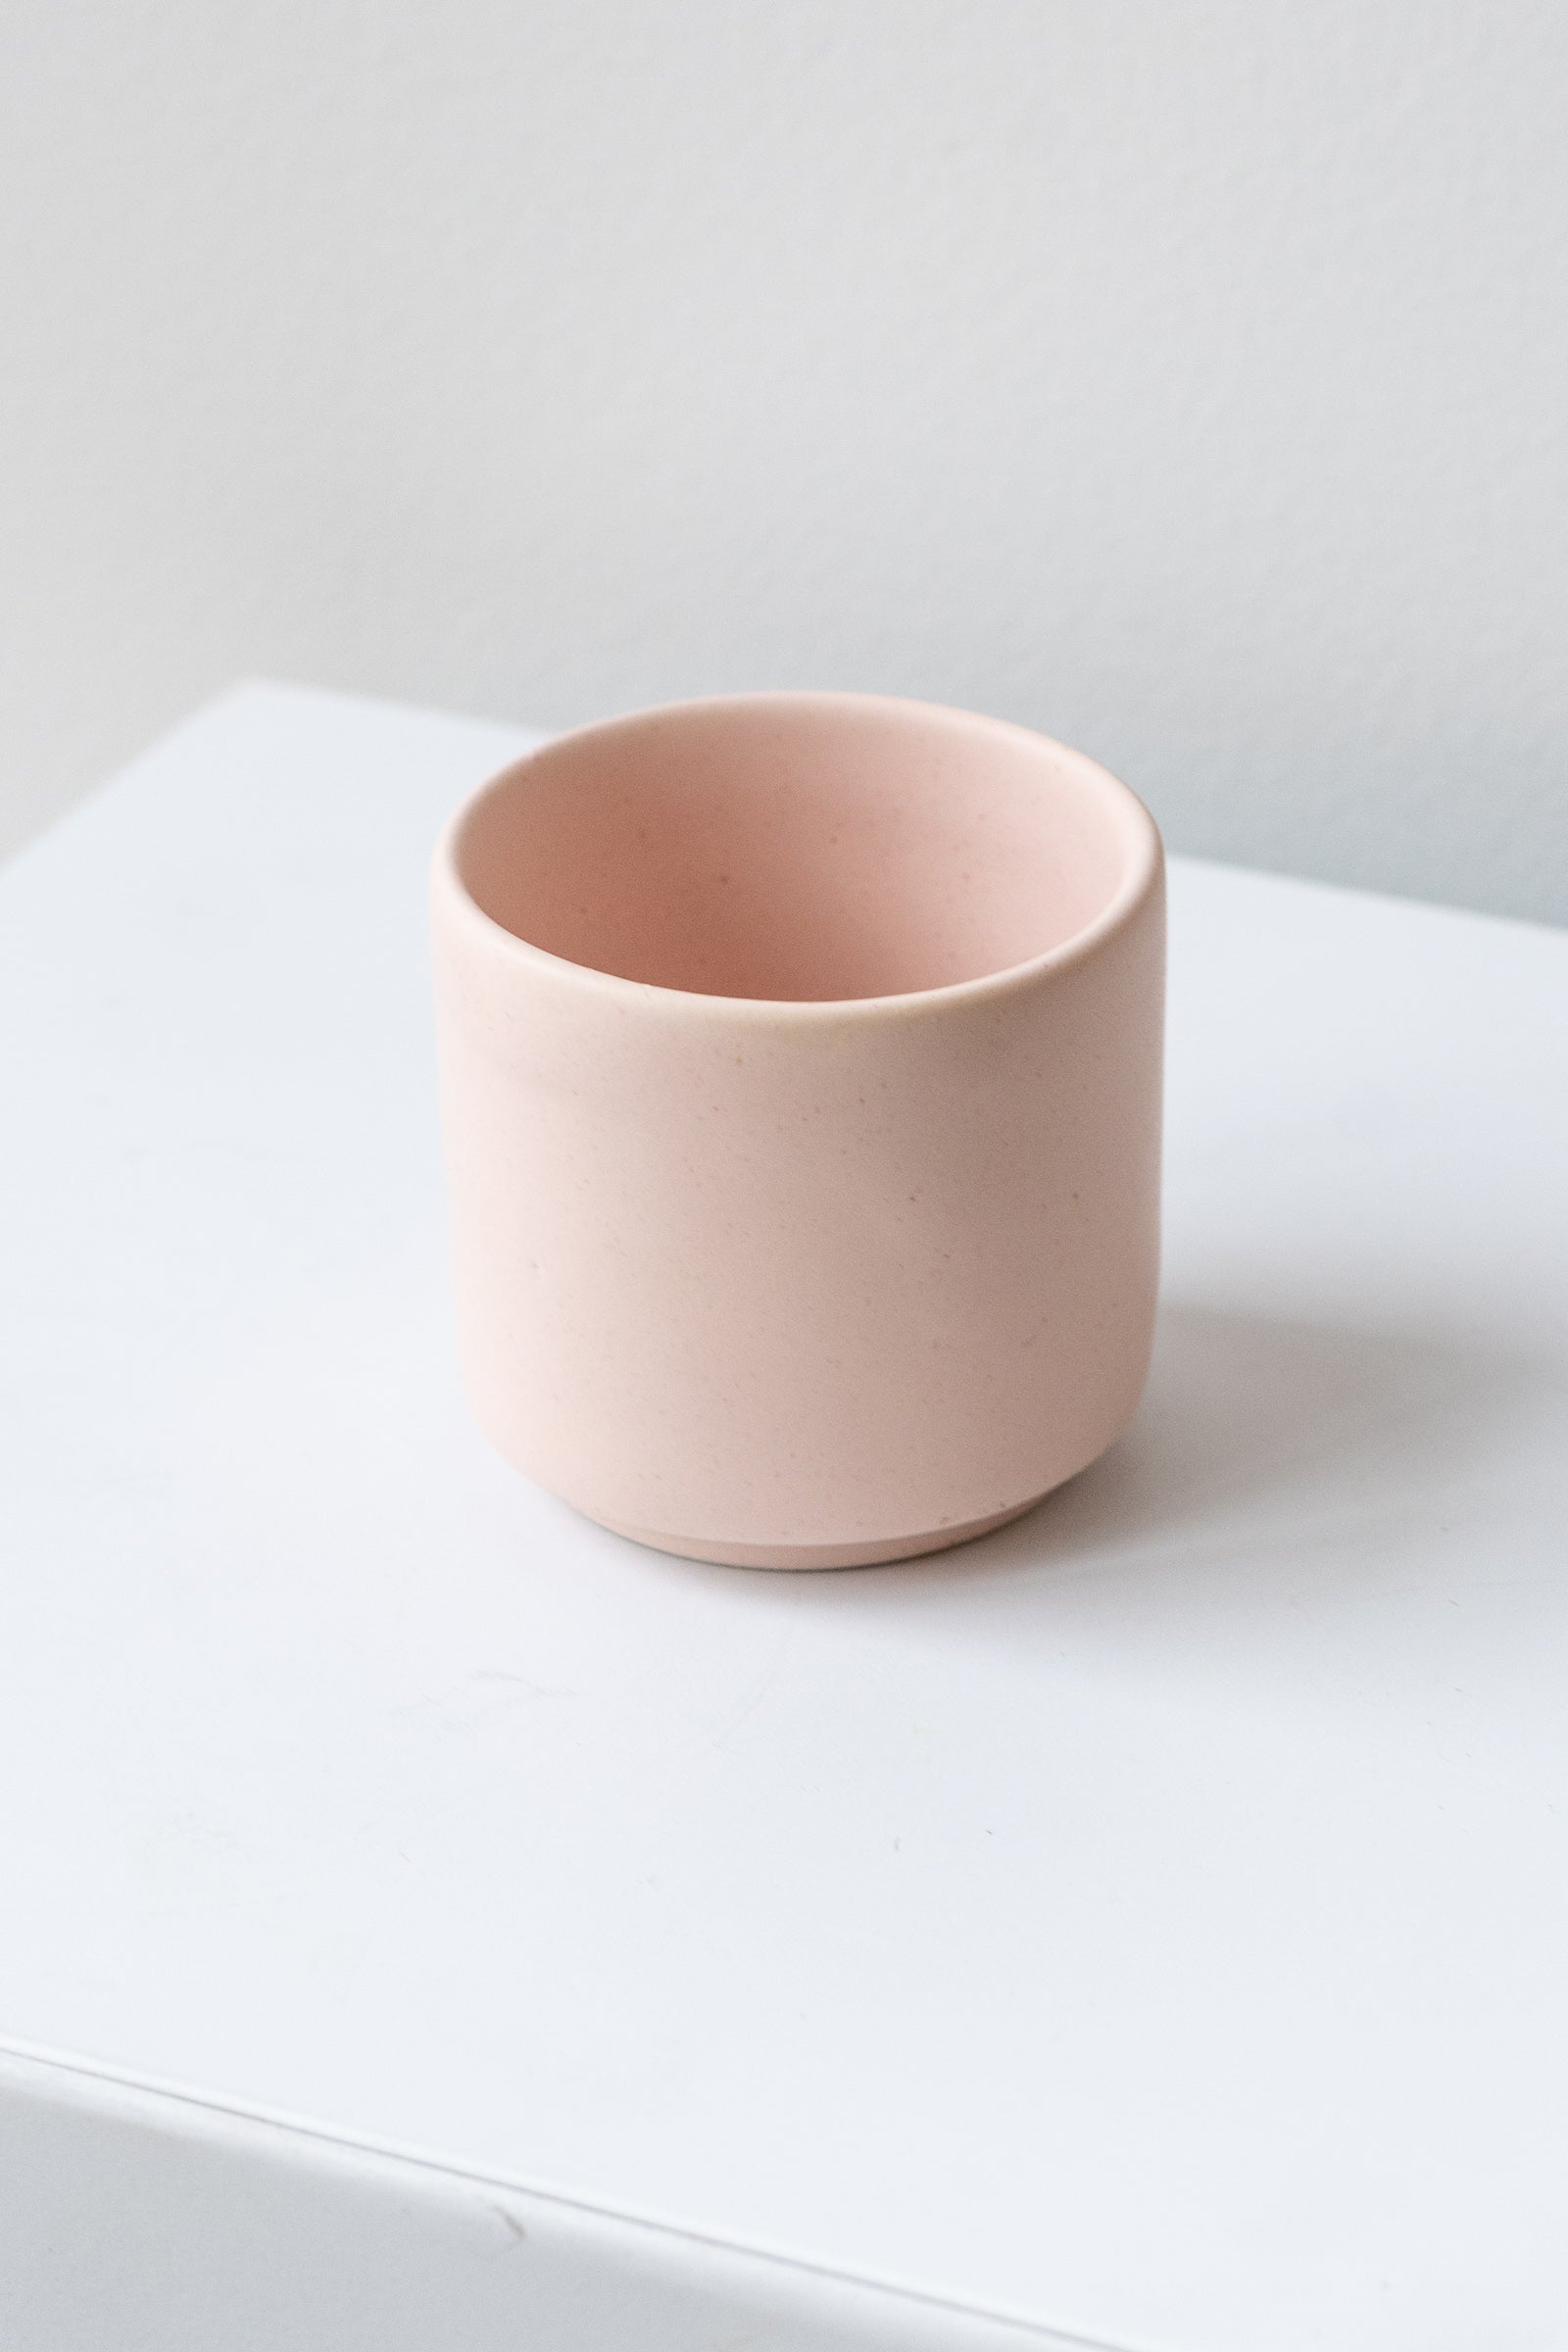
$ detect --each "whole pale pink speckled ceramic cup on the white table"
[435,694,1163,1569]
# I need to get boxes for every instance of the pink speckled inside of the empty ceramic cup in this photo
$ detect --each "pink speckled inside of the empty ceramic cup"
[454,694,1154,1002]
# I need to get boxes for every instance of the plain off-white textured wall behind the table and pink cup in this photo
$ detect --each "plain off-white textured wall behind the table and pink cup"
[0,0,1568,919]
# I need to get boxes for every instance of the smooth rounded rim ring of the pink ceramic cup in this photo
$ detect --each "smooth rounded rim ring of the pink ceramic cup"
[432,687,1163,1025]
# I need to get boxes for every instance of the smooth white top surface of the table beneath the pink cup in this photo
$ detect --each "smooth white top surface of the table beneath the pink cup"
[0,689,1568,2352]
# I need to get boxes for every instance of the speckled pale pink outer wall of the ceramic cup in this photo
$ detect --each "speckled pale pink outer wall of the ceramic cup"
[435,863,1163,1562]
